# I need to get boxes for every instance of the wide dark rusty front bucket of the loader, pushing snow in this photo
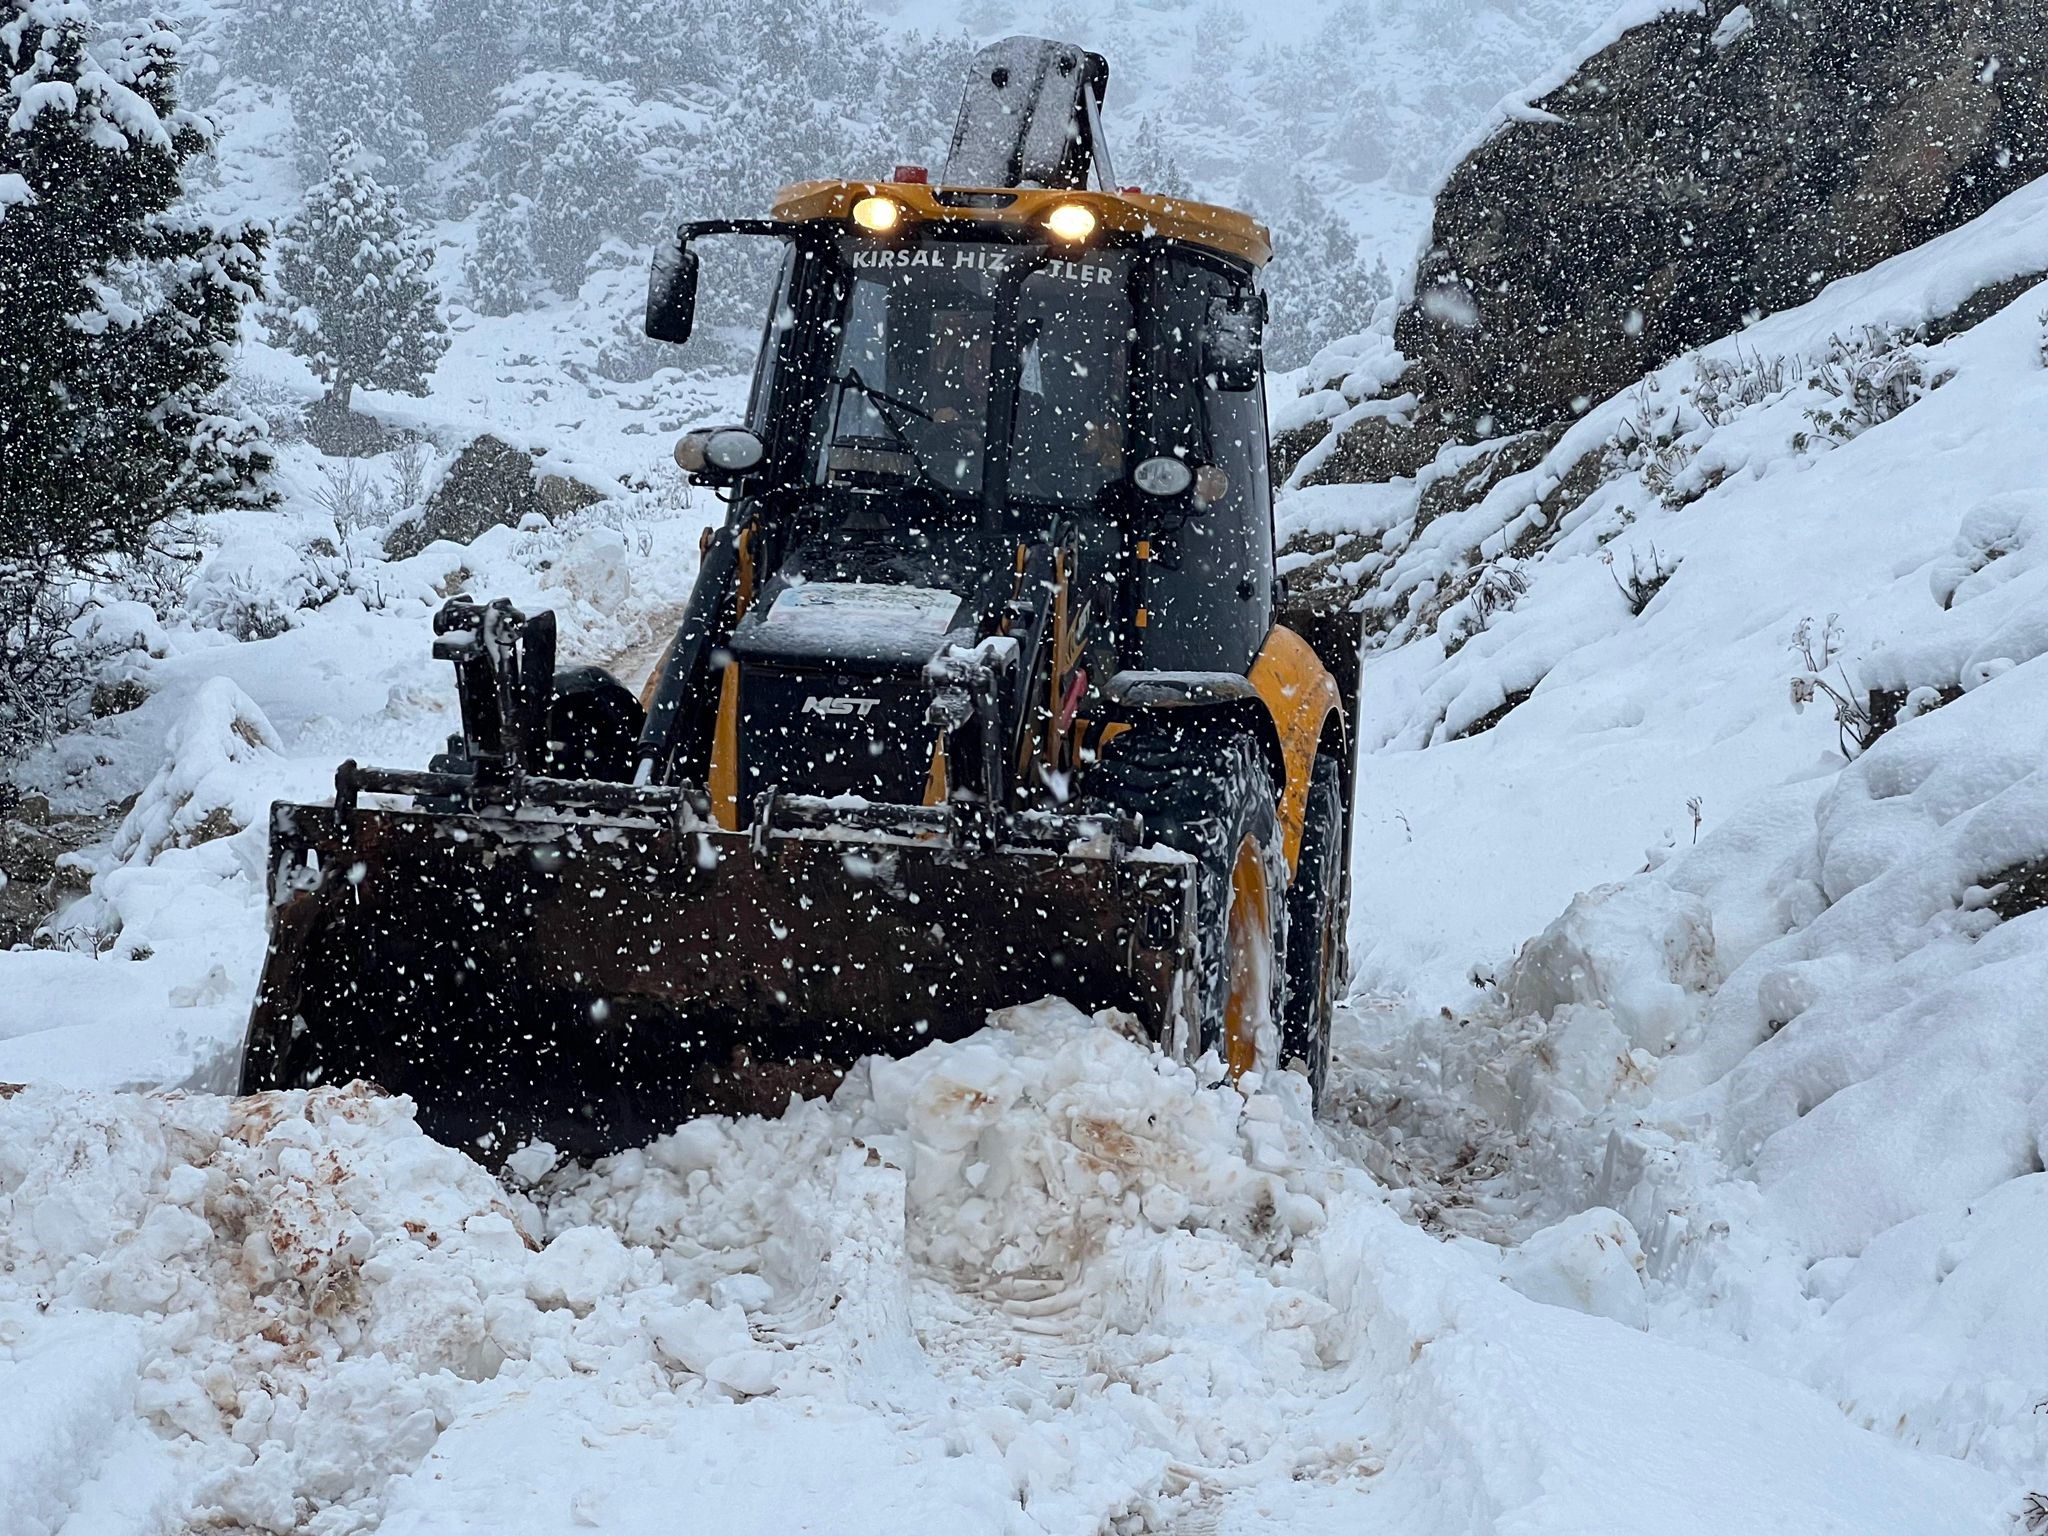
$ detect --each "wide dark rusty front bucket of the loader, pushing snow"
[242,803,1194,1159]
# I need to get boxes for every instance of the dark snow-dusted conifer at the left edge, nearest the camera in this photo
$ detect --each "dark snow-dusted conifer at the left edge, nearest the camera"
[0,0,270,571]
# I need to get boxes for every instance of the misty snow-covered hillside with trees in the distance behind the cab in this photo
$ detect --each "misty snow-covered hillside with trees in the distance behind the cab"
[151,0,1608,382]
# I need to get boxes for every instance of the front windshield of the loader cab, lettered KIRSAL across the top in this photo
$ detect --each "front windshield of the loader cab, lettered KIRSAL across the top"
[815,240,1135,506]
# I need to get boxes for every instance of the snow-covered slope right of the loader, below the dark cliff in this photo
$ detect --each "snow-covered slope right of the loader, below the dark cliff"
[1286,167,2048,1479]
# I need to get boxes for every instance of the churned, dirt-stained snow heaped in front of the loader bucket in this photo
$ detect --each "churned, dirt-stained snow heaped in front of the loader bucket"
[0,1004,1999,1536]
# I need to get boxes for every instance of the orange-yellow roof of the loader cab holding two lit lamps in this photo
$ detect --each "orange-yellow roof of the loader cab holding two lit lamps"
[772,180,1274,268]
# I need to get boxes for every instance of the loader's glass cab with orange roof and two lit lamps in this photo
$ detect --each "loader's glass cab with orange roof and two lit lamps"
[657,182,1272,674]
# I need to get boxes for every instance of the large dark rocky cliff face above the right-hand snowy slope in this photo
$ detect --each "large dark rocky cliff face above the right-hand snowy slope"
[1395,0,2048,436]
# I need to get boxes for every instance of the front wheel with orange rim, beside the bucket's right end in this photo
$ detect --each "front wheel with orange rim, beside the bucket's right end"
[1081,727,1286,1079]
